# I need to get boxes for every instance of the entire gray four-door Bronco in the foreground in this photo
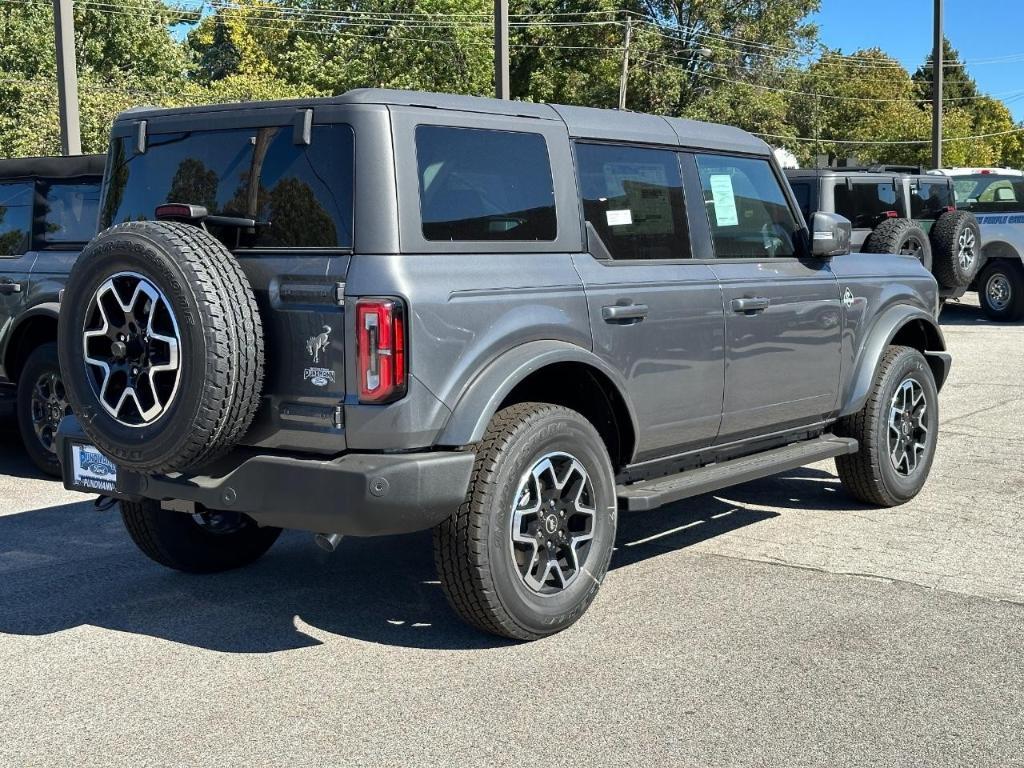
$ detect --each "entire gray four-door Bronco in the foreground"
[59,90,949,639]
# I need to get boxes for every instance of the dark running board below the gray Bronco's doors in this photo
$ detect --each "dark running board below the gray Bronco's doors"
[616,434,858,511]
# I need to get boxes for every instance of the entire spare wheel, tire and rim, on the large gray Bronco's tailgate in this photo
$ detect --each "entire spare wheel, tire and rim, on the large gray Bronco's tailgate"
[58,221,263,474]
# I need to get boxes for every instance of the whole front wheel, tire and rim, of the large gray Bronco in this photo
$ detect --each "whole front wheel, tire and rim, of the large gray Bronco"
[836,347,939,507]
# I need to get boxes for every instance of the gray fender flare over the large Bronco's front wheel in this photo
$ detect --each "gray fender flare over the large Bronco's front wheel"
[839,304,951,416]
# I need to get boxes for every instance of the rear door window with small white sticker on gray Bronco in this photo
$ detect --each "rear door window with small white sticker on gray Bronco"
[577,143,690,260]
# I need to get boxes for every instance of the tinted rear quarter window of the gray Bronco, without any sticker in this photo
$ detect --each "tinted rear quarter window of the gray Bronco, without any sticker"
[416,125,557,241]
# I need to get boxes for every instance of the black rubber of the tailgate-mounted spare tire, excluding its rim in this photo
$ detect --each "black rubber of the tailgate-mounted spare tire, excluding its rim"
[58,221,264,474]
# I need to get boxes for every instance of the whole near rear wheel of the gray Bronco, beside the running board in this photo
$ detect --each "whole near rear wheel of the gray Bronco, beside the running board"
[434,402,616,640]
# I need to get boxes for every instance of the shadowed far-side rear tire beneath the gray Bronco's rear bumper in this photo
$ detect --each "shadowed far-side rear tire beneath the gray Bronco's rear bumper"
[120,500,281,573]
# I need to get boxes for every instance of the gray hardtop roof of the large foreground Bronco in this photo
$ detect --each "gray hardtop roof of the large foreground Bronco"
[116,88,771,156]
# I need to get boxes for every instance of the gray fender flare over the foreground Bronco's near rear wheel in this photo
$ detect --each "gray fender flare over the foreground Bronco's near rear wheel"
[437,340,637,445]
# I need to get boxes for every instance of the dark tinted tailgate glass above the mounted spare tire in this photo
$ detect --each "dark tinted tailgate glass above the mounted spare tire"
[102,125,353,248]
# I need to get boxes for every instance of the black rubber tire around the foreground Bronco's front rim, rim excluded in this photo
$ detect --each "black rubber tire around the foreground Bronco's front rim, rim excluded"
[836,346,939,507]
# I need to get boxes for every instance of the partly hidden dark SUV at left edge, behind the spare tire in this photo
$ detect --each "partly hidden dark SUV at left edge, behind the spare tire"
[0,155,103,477]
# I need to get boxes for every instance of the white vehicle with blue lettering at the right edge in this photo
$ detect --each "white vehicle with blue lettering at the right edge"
[929,168,1024,321]
